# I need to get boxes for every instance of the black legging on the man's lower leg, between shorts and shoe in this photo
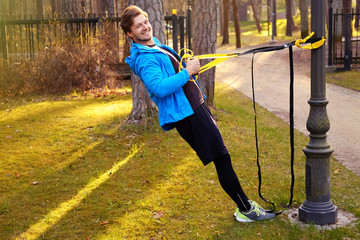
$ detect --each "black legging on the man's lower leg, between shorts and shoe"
[214,154,251,212]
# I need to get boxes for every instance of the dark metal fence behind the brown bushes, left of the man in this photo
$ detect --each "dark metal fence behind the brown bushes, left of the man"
[0,13,121,61]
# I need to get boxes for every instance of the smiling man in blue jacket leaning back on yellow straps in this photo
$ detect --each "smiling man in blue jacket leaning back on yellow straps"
[121,6,275,222]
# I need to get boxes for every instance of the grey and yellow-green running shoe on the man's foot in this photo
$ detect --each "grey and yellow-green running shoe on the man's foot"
[234,202,275,222]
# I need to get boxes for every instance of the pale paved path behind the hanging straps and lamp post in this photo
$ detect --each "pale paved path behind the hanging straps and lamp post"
[216,45,360,176]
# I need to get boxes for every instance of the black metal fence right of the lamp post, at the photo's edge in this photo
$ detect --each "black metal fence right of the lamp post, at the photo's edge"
[328,7,360,70]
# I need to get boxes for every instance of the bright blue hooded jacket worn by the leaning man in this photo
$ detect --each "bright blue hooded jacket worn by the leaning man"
[125,38,194,131]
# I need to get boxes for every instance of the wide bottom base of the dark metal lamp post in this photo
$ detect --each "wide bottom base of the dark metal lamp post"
[299,200,338,225]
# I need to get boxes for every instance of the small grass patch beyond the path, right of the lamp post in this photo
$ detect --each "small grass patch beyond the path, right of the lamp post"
[326,71,360,91]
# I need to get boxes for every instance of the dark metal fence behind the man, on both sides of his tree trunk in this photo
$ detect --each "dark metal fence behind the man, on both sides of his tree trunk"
[0,11,191,62]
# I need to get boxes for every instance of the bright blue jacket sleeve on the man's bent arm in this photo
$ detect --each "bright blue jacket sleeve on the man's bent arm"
[136,54,190,97]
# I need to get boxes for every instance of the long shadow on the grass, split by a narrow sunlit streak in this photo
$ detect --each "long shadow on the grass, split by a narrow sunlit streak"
[1,116,200,239]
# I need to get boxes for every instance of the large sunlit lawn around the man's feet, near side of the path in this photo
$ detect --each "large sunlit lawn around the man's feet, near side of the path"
[0,81,360,240]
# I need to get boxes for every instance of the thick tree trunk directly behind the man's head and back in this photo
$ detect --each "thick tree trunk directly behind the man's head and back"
[128,0,165,123]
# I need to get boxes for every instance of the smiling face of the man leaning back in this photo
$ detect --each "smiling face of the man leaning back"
[128,14,152,44]
